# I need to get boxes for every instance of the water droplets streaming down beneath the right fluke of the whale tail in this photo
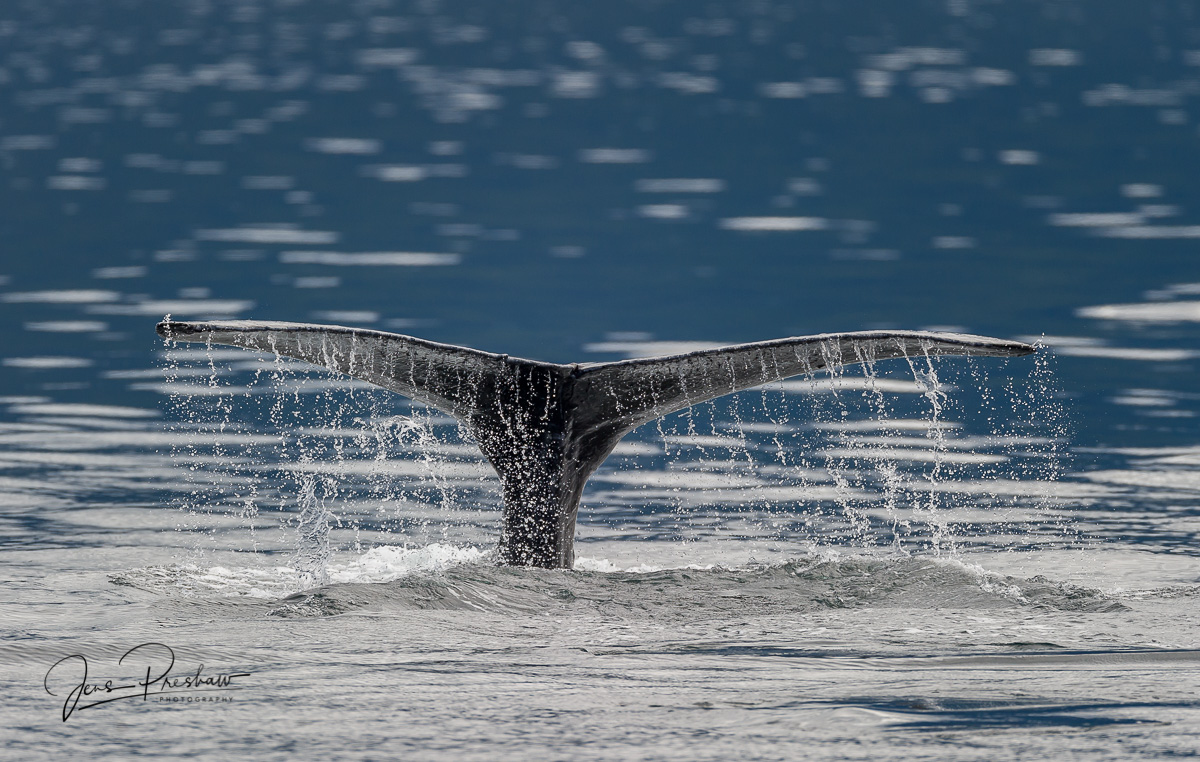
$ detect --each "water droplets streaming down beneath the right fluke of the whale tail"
[595,343,1067,554]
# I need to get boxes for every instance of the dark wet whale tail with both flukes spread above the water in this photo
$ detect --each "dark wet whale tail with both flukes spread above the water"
[157,320,1034,568]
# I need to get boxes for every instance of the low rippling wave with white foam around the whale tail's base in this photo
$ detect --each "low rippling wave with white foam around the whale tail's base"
[110,544,1124,618]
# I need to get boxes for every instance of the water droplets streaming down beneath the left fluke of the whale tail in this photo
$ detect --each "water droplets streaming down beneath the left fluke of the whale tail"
[164,347,498,584]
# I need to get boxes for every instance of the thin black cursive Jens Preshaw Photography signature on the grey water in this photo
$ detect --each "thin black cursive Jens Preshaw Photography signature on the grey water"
[42,643,250,722]
